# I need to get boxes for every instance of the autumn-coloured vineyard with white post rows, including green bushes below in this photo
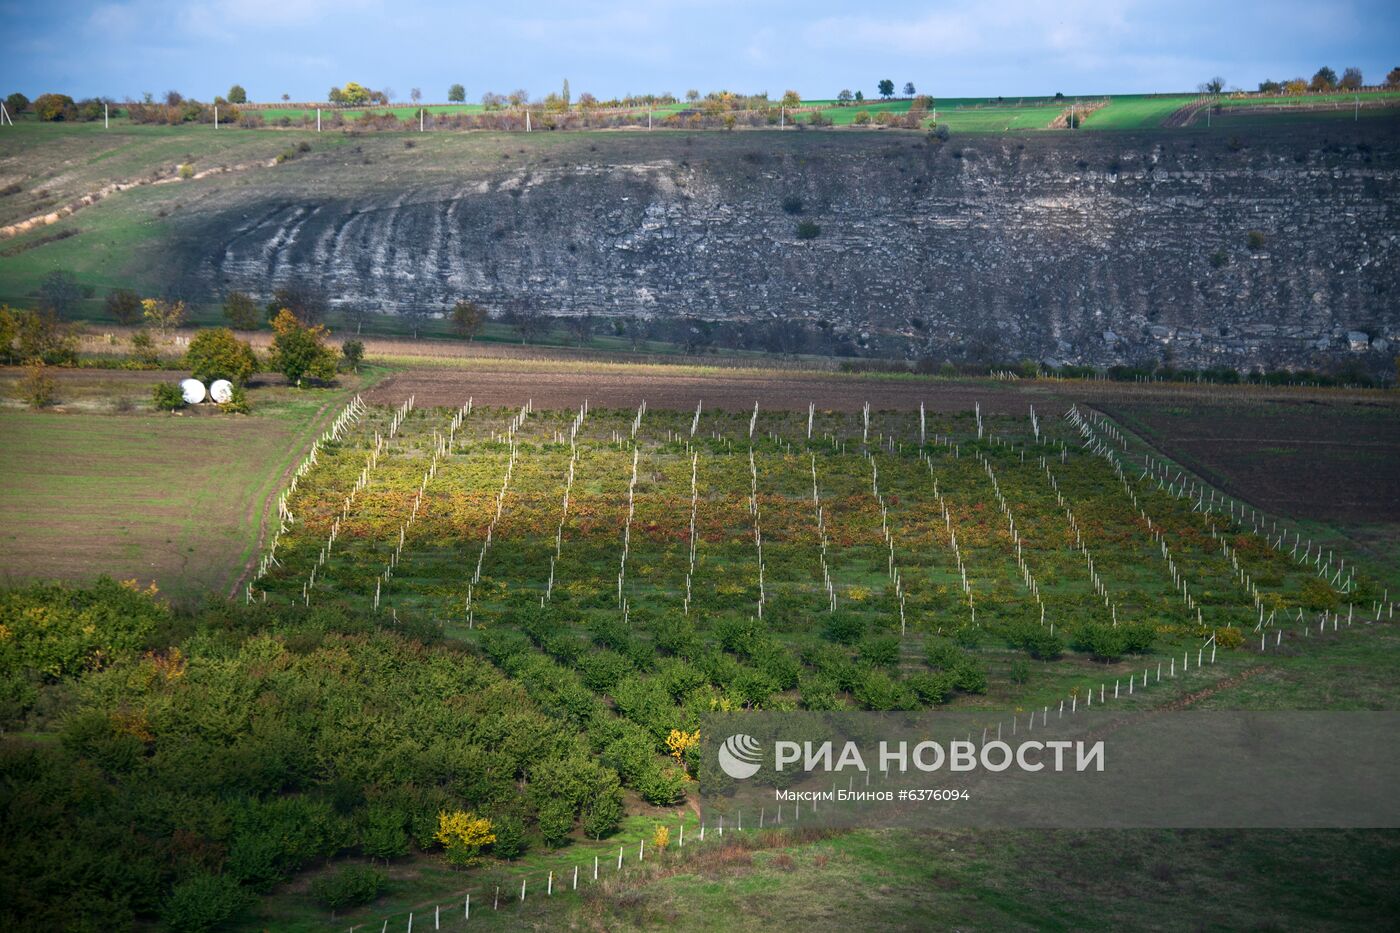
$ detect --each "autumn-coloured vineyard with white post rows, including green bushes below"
[245,399,1387,803]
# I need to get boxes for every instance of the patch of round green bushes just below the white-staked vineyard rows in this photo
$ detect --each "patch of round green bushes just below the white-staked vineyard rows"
[470,605,1155,722]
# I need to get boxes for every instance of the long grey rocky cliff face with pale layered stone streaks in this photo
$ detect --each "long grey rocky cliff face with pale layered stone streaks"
[192,120,1400,367]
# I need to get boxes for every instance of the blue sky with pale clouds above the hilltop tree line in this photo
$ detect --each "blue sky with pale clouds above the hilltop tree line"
[0,0,1400,101]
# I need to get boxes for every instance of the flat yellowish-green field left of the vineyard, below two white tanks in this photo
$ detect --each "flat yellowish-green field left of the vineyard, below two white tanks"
[0,373,375,601]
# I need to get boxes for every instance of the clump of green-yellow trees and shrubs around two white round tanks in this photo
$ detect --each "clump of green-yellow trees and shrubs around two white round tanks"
[151,310,364,413]
